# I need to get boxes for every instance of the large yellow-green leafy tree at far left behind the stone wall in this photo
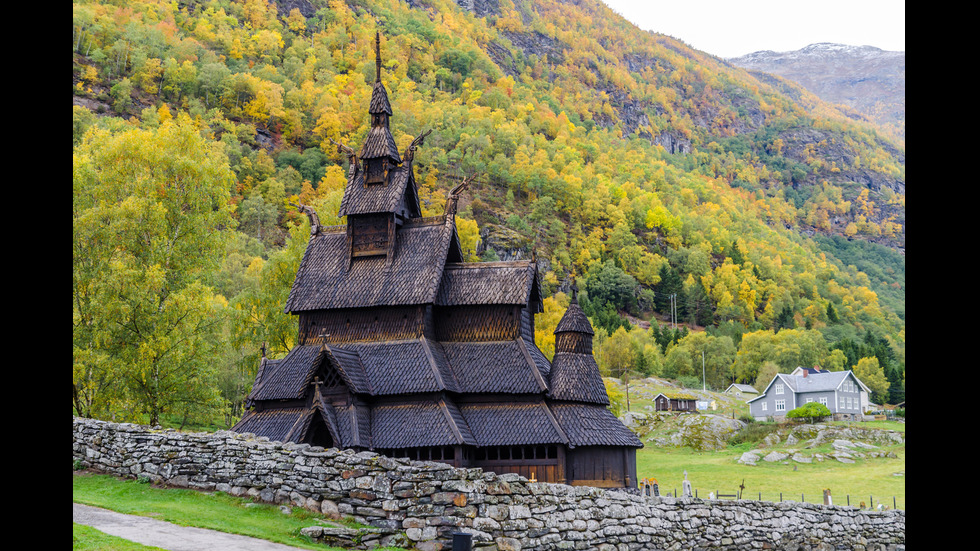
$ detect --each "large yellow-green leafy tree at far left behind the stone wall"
[72,117,234,424]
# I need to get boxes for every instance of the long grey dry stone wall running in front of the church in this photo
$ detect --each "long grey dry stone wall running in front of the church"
[72,417,905,551]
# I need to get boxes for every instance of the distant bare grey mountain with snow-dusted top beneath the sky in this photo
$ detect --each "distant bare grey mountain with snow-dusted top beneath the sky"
[728,43,905,139]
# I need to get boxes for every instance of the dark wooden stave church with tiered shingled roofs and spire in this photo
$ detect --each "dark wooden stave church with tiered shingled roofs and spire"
[233,36,643,487]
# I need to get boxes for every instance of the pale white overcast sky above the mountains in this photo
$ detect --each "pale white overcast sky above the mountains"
[602,0,905,58]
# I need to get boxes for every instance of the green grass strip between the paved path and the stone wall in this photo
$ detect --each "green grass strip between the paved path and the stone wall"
[72,472,352,551]
